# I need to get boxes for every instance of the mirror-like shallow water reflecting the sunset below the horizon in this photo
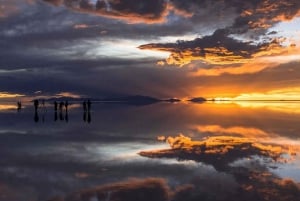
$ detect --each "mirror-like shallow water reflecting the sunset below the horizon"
[0,102,300,201]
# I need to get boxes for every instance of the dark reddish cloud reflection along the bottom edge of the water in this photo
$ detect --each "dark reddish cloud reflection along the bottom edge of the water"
[45,167,300,201]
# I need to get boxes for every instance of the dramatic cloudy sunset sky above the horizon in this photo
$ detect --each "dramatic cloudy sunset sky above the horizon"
[0,0,300,100]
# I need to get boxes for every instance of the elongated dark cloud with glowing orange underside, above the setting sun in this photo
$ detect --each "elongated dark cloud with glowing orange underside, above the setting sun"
[139,30,288,66]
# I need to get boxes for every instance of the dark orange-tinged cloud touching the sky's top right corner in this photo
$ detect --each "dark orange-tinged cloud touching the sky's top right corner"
[171,0,300,33]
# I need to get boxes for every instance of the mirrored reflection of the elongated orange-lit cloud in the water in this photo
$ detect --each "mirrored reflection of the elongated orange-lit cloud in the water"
[140,135,288,170]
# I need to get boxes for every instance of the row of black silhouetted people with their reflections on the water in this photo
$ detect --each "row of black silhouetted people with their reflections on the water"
[30,99,92,123]
